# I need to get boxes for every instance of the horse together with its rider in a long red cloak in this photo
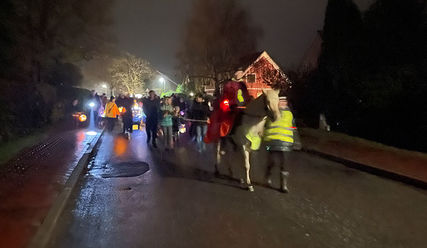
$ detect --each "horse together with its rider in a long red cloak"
[205,81,280,191]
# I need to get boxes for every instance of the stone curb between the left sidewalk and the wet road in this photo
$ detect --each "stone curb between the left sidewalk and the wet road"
[27,131,104,248]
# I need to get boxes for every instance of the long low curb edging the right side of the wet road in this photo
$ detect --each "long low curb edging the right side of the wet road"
[301,148,427,189]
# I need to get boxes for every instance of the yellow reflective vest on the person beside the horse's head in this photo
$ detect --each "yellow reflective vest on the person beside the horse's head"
[263,109,295,143]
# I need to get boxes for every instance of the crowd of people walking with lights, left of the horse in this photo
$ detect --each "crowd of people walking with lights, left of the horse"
[89,90,212,151]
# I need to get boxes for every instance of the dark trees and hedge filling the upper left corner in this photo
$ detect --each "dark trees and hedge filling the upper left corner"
[0,0,113,142]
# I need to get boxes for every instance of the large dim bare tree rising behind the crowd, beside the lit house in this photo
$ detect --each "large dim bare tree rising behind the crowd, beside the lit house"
[178,0,261,91]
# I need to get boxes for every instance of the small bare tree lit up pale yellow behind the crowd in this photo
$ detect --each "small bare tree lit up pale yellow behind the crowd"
[109,53,155,94]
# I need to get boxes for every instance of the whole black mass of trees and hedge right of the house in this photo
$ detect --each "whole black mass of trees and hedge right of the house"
[293,0,427,151]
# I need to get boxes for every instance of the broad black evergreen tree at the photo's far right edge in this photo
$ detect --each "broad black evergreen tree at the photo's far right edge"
[361,0,427,150]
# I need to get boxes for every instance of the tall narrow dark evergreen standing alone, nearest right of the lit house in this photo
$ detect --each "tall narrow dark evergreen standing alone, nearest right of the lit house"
[317,0,363,132]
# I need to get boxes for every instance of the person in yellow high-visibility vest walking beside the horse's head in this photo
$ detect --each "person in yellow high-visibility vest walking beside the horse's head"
[263,97,297,193]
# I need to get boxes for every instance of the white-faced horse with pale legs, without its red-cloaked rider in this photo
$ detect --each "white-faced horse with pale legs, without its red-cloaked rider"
[215,90,280,191]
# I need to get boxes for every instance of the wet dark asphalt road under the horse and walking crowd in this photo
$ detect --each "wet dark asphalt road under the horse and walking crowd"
[50,132,427,248]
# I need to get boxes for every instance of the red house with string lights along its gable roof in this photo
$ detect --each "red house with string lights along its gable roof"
[204,51,289,98]
